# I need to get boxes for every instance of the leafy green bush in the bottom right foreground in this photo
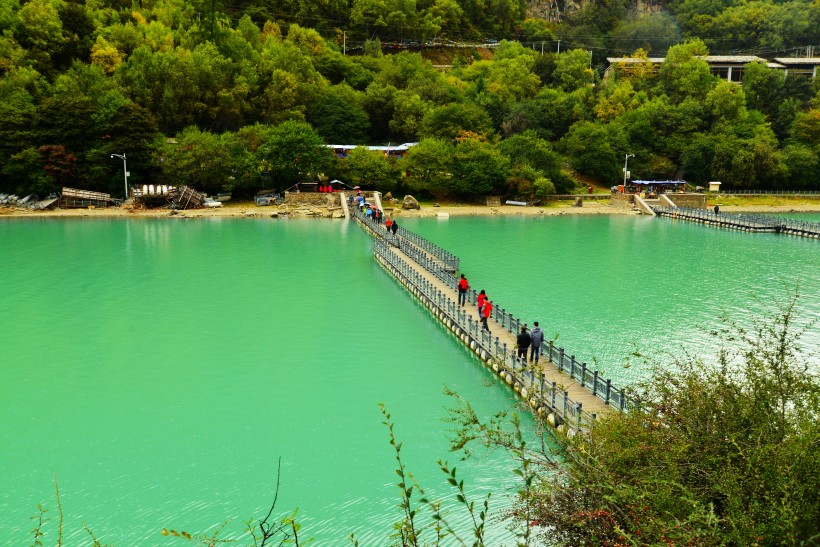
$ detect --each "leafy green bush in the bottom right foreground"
[533,302,820,545]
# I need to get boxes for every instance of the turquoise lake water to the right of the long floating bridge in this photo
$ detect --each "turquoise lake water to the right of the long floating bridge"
[402,215,820,382]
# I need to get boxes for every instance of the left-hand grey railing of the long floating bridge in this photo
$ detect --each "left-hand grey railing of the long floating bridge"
[374,238,597,429]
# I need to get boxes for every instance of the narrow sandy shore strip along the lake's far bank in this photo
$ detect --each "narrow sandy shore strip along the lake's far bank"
[0,200,820,218]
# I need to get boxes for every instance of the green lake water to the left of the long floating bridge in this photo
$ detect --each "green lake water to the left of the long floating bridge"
[0,219,524,545]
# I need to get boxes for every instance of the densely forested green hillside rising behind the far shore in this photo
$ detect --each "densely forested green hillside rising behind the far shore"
[0,0,820,199]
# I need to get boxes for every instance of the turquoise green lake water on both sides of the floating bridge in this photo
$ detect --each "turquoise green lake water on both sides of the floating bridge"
[0,217,820,546]
